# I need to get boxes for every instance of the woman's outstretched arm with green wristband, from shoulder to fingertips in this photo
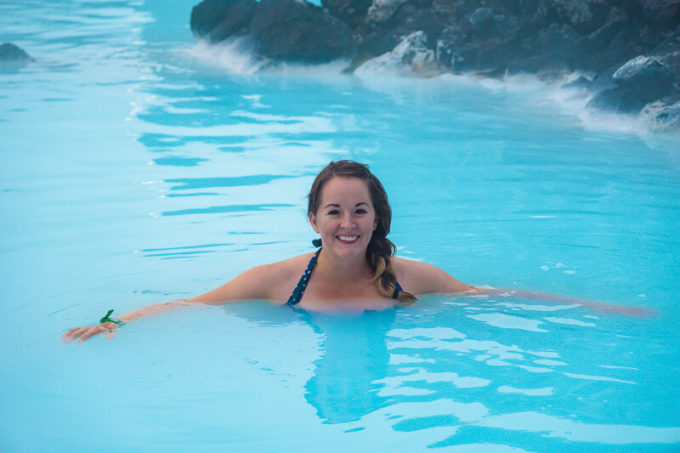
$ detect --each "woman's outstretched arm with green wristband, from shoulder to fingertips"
[62,263,281,343]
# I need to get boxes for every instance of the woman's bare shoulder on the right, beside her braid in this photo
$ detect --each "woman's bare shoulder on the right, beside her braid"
[392,257,472,295]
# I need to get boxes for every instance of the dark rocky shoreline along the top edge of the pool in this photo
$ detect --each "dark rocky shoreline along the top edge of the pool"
[191,0,680,132]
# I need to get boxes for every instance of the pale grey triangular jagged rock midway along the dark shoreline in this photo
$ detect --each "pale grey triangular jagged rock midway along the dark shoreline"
[354,31,441,76]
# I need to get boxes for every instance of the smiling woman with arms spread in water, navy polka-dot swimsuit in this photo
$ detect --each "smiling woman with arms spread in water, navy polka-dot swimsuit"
[62,160,644,343]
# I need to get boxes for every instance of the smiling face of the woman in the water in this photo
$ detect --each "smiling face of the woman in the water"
[309,176,377,257]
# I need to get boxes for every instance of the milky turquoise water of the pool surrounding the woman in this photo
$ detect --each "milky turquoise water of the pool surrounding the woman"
[0,1,680,452]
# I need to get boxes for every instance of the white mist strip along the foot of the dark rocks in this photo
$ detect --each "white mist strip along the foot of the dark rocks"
[186,38,677,137]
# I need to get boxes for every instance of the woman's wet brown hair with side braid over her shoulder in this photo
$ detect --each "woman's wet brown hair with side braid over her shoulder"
[307,160,416,302]
